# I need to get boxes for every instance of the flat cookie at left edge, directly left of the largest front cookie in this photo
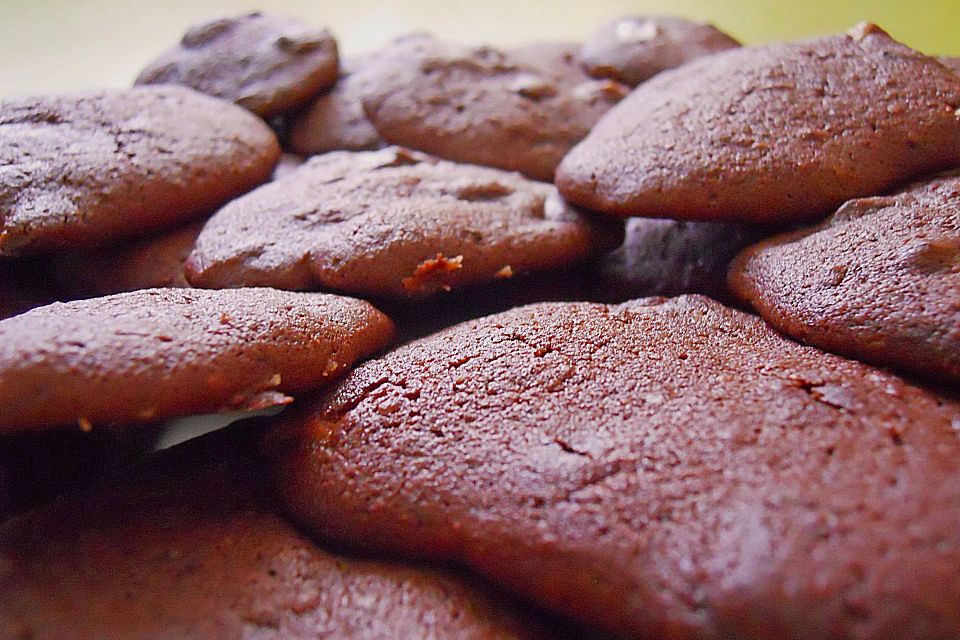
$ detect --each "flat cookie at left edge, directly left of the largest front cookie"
[0,289,393,431]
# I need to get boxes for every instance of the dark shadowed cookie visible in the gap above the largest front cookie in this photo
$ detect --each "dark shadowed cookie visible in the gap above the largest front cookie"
[591,218,761,300]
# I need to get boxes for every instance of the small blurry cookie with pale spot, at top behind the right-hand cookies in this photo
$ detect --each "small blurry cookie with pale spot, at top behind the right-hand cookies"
[580,16,740,87]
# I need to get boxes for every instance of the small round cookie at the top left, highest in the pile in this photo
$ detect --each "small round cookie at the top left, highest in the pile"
[136,13,338,118]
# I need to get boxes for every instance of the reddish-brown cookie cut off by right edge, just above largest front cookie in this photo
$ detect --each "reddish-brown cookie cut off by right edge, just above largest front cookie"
[730,170,960,384]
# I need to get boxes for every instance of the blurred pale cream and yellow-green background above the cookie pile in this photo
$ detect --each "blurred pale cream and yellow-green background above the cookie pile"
[0,0,960,95]
